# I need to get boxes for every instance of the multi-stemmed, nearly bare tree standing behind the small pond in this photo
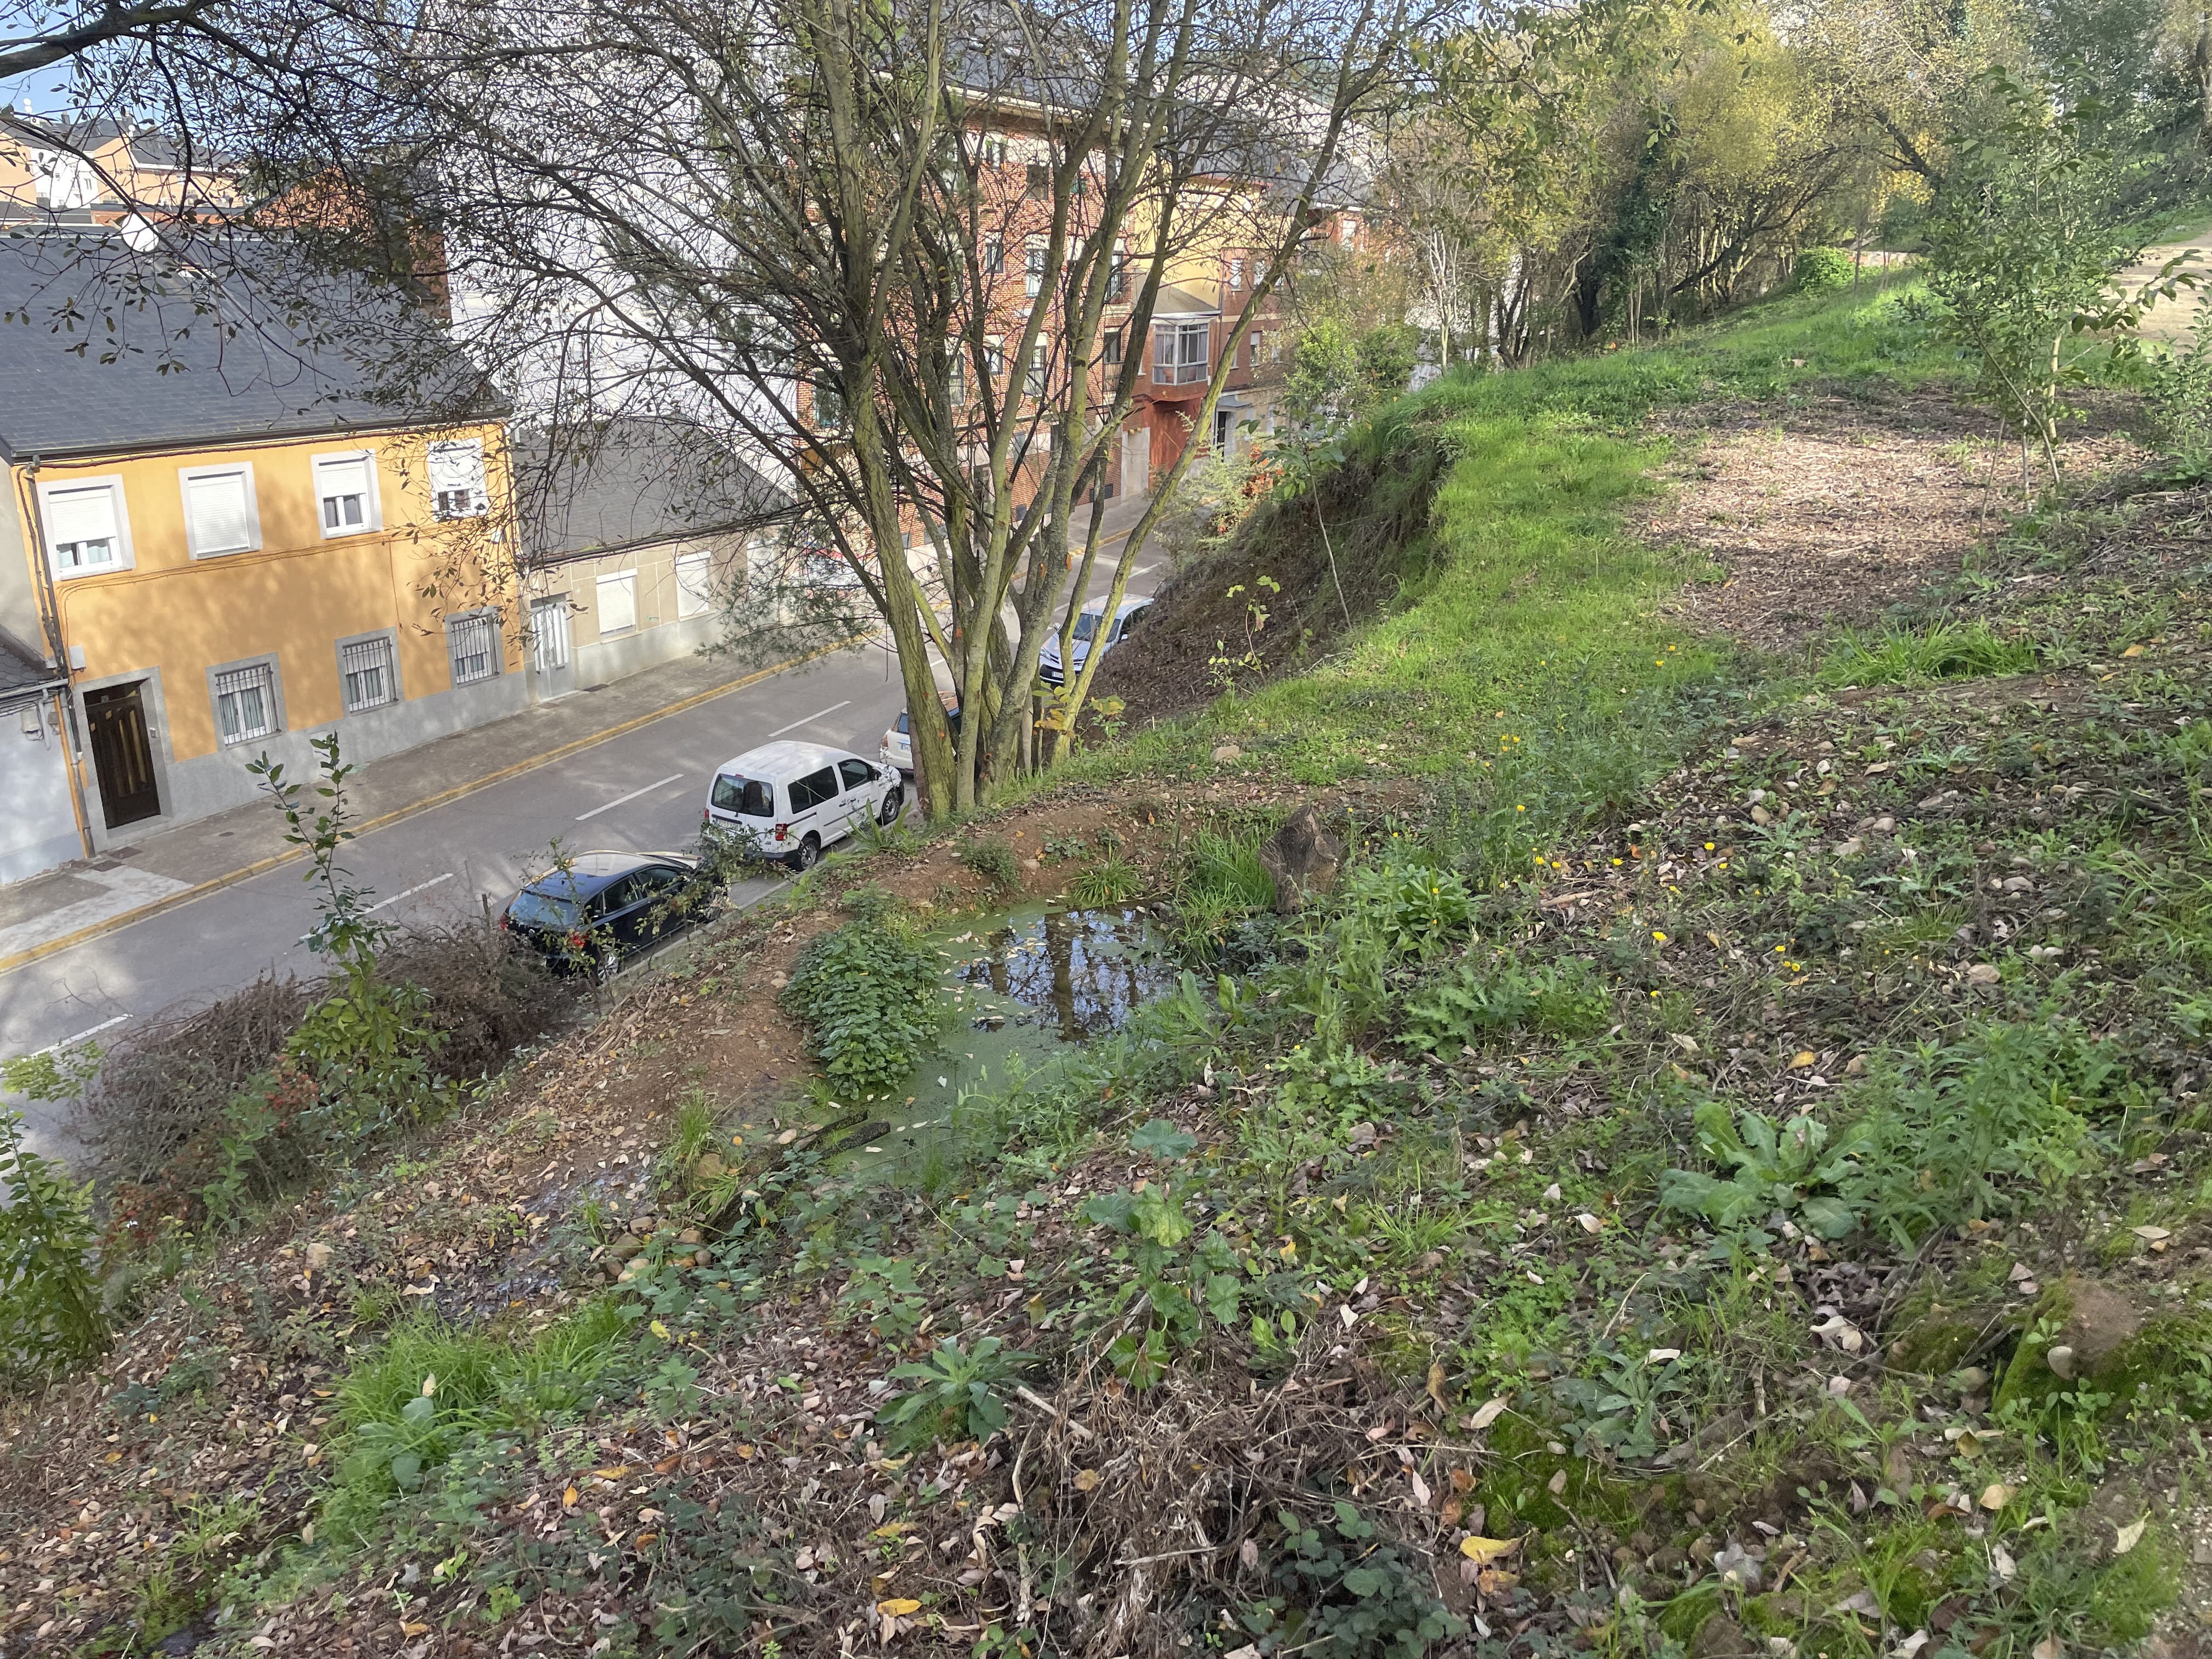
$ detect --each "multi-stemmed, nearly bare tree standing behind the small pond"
[177,0,1434,812]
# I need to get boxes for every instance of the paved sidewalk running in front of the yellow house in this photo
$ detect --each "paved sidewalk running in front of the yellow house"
[0,641,832,973]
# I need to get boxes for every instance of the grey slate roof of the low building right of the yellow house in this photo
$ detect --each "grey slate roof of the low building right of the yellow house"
[511,418,792,562]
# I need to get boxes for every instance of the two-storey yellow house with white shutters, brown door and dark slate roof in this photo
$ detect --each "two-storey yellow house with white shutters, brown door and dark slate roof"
[0,244,529,881]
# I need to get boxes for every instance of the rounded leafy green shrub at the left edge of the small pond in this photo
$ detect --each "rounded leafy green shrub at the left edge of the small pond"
[781,916,942,1093]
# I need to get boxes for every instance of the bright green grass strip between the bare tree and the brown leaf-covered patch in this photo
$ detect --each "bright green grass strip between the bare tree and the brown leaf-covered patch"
[1075,294,1951,821]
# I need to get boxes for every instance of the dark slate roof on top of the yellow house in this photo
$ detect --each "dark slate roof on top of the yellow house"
[0,228,504,460]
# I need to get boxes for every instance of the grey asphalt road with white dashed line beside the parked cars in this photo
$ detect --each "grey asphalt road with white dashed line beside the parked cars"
[0,646,905,1153]
